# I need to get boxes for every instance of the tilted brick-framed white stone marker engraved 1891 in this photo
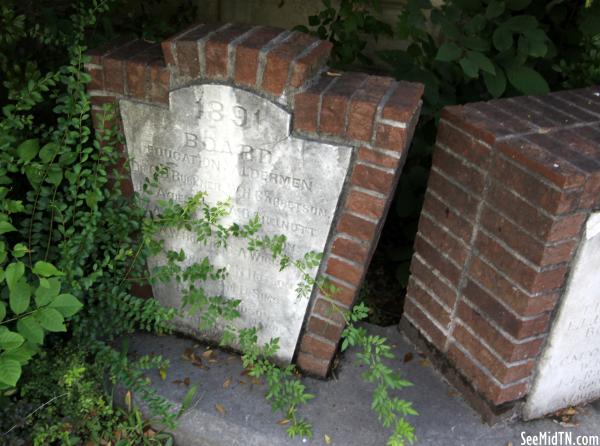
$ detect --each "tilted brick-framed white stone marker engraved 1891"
[87,24,422,376]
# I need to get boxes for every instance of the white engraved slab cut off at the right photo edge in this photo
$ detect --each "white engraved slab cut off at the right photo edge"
[524,212,600,419]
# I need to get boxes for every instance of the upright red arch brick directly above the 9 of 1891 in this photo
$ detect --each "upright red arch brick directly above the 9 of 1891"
[235,27,284,87]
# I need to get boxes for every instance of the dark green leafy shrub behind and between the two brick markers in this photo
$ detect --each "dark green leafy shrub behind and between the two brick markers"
[300,0,600,287]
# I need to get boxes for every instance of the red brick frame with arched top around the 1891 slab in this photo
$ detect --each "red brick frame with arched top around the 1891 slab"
[87,24,423,376]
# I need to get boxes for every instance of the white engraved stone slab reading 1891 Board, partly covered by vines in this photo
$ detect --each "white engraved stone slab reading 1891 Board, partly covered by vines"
[120,84,352,362]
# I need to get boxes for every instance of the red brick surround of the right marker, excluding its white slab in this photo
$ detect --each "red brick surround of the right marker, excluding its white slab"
[402,87,600,410]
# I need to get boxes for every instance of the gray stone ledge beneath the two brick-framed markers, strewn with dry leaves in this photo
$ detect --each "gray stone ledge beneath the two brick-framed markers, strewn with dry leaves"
[122,326,600,446]
